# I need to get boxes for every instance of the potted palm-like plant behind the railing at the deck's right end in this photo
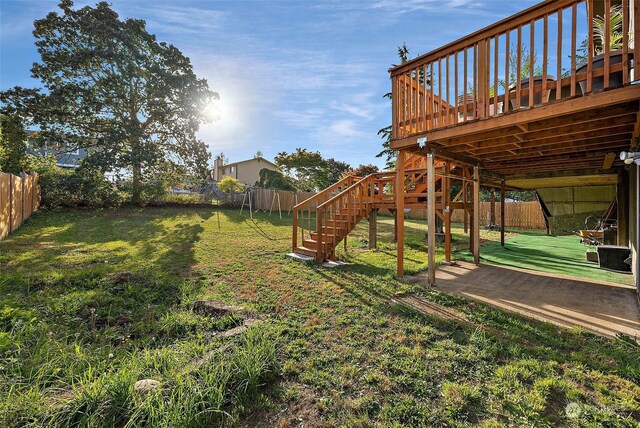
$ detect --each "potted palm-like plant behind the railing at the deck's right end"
[576,5,633,95]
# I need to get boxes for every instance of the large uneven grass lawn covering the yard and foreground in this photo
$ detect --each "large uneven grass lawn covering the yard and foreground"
[0,208,640,427]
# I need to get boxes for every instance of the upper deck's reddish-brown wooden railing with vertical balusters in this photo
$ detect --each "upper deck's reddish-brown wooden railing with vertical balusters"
[390,0,640,139]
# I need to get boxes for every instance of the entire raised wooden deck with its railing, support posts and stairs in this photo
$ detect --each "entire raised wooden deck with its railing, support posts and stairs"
[292,0,640,284]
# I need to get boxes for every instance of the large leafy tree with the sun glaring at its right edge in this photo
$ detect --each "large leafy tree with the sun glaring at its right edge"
[1,0,218,201]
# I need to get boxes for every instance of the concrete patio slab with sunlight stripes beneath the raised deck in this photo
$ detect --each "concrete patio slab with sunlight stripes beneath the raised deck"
[435,262,640,340]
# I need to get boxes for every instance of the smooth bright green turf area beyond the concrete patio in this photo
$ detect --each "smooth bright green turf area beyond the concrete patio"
[456,231,633,284]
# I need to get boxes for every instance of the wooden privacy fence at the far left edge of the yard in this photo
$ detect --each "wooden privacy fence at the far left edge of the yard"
[0,172,40,239]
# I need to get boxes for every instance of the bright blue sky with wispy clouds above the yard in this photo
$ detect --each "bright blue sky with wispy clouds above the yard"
[0,0,536,166]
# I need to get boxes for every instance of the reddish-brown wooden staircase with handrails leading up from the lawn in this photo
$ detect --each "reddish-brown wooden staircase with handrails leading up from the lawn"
[292,155,444,261]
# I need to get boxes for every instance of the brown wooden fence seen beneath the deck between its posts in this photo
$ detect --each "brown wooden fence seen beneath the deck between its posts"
[390,201,546,230]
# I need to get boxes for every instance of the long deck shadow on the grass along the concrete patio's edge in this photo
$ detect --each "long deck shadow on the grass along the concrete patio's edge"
[304,244,640,382]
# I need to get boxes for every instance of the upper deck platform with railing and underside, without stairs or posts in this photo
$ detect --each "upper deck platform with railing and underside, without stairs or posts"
[390,0,640,179]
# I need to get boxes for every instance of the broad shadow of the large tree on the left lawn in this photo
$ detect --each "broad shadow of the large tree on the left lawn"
[0,208,222,346]
